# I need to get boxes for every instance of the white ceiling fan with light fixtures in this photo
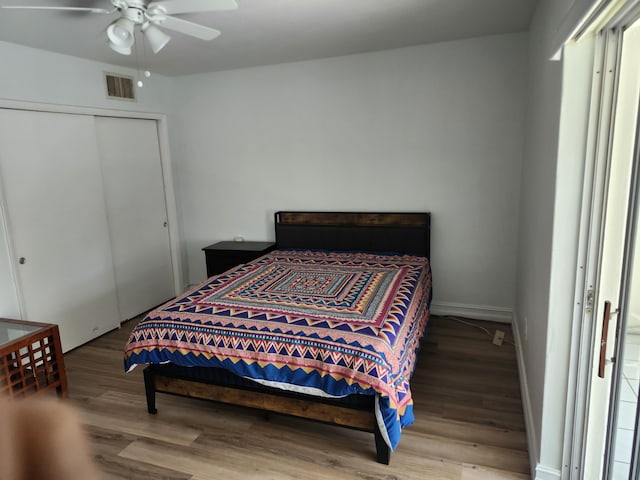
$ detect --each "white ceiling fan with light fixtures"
[2,0,238,55]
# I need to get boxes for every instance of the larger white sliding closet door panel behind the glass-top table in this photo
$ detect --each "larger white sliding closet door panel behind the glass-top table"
[0,109,119,351]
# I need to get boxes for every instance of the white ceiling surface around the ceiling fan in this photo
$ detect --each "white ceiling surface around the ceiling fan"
[0,0,537,75]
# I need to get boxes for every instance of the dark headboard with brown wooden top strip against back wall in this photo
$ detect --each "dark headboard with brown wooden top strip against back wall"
[275,212,431,257]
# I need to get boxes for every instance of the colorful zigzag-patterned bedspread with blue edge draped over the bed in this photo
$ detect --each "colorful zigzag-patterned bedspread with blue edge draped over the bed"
[124,250,431,449]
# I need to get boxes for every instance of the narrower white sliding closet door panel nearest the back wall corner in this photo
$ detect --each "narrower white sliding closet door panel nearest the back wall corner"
[95,117,175,320]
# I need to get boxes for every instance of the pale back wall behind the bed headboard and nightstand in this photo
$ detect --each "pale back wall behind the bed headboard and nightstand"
[172,34,527,316]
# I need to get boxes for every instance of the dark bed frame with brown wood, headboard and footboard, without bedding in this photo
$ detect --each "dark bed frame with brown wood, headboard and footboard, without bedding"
[144,211,431,464]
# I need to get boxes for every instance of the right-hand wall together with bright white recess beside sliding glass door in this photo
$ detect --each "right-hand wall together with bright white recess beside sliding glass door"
[514,0,593,480]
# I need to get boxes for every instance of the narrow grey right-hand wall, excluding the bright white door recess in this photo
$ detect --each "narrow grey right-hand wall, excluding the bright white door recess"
[514,1,562,478]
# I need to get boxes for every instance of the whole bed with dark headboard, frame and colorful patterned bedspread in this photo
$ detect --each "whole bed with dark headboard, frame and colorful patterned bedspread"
[125,212,431,464]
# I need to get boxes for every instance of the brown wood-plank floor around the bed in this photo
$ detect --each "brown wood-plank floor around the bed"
[65,317,529,480]
